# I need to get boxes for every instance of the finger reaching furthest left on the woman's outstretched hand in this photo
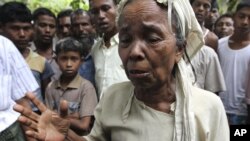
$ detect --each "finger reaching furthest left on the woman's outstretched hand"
[13,104,39,121]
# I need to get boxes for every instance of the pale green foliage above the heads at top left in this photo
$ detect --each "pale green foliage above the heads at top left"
[0,0,89,15]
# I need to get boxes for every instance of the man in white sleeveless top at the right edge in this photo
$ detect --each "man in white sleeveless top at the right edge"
[218,0,250,125]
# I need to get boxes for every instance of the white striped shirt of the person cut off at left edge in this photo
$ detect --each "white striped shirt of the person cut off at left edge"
[0,36,38,132]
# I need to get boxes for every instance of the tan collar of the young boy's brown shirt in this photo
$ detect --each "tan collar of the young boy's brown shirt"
[55,74,82,89]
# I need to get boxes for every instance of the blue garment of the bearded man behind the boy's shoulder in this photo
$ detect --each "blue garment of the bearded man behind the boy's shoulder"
[78,54,95,87]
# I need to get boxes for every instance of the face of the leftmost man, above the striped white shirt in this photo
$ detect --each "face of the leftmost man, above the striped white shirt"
[2,21,33,50]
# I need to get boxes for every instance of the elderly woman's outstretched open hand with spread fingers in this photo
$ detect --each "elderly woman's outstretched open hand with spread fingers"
[14,93,70,141]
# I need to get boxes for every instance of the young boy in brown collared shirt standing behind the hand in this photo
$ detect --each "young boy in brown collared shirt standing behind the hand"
[45,37,97,135]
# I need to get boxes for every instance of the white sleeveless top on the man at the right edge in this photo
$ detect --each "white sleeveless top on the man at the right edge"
[218,37,250,115]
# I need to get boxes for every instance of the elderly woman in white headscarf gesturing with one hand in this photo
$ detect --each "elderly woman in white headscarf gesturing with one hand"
[15,0,229,141]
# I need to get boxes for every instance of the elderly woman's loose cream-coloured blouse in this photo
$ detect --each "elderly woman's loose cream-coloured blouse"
[85,82,229,141]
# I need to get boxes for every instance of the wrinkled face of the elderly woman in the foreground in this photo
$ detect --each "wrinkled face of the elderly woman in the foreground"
[119,0,182,89]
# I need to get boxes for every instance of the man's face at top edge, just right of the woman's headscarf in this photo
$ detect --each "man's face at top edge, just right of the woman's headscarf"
[192,0,211,24]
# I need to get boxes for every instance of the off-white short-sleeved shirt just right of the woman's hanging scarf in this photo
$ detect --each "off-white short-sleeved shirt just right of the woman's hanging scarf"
[188,46,226,93]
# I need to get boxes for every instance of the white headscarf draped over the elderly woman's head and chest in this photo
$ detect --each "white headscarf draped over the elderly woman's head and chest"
[117,0,204,141]
